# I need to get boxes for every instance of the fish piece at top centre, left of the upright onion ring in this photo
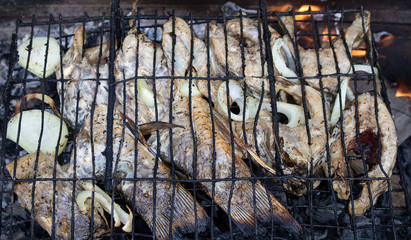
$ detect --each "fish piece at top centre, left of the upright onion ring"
[208,16,281,94]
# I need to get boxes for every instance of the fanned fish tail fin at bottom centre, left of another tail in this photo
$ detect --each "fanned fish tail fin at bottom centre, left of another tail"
[150,183,209,240]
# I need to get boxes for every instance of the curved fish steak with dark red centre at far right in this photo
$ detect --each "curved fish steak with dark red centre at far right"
[324,93,398,216]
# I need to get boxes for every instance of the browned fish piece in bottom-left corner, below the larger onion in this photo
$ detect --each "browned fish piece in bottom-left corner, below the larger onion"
[7,152,109,239]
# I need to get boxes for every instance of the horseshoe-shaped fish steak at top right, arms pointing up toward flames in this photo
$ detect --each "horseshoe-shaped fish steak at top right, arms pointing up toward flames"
[281,11,371,94]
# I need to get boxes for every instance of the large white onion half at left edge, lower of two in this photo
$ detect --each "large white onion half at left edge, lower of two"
[7,109,68,156]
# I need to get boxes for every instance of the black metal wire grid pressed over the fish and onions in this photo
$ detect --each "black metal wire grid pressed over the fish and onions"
[0,1,411,239]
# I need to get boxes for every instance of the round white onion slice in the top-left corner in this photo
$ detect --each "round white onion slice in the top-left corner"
[17,37,60,78]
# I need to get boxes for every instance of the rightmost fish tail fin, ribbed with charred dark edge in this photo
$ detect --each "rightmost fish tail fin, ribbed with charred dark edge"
[255,182,303,239]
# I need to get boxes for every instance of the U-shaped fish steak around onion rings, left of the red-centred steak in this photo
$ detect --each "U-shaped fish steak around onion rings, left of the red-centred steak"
[233,78,330,196]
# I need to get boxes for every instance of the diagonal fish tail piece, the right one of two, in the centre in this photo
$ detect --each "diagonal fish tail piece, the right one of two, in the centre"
[153,97,302,236]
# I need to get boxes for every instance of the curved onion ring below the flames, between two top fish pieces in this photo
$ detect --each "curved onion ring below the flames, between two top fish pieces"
[271,38,300,84]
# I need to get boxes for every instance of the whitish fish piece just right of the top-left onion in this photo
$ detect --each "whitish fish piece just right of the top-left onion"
[56,26,110,129]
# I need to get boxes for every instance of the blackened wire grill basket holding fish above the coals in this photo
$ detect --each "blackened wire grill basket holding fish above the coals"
[0,1,411,239]
